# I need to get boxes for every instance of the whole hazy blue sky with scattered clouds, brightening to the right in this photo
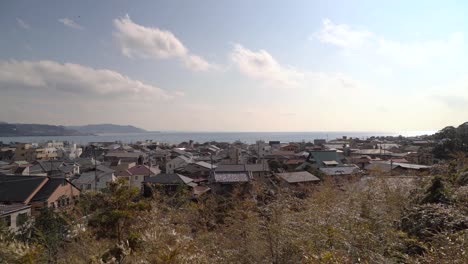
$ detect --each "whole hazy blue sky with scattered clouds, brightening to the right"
[0,0,468,132]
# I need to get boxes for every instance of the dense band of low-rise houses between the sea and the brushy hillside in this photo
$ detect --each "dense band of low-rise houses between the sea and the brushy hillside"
[0,134,434,230]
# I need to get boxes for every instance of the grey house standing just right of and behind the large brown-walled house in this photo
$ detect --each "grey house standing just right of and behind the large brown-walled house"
[72,165,117,192]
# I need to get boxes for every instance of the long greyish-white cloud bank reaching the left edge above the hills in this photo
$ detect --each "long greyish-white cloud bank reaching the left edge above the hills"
[0,61,172,100]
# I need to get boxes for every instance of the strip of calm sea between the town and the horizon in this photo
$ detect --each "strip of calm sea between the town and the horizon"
[0,131,435,145]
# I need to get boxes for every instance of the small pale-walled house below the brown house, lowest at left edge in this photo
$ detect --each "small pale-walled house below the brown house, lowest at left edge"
[0,203,31,232]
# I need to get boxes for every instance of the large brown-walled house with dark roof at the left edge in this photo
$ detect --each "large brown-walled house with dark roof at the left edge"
[0,175,80,215]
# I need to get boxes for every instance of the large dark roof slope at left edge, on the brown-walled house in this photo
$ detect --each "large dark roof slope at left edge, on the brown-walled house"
[0,175,47,202]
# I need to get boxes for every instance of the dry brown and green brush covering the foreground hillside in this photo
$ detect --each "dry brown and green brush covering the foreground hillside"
[0,164,468,263]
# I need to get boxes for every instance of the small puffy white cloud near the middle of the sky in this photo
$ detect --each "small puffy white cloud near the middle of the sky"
[230,44,303,88]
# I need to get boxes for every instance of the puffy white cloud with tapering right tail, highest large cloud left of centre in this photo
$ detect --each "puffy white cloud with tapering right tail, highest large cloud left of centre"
[114,15,215,71]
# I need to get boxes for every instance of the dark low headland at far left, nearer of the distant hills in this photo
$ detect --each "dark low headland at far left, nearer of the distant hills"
[0,122,86,137]
